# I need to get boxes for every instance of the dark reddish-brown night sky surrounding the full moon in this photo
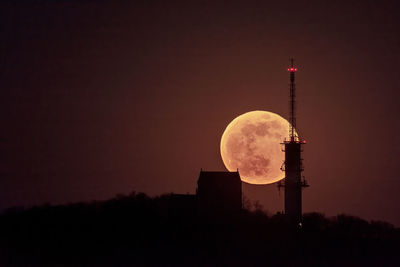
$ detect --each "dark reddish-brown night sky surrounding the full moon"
[0,0,400,225]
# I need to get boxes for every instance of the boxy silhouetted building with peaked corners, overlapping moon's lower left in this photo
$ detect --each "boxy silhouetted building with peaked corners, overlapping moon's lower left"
[196,171,242,218]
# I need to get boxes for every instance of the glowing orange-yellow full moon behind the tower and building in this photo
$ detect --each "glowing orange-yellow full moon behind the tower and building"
[220,110,296,184]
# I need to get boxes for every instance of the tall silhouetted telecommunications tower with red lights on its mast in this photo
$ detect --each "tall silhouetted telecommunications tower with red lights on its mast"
[278,59,308,224]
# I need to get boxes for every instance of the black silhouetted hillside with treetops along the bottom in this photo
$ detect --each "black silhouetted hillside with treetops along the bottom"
[0,194,400,266]
